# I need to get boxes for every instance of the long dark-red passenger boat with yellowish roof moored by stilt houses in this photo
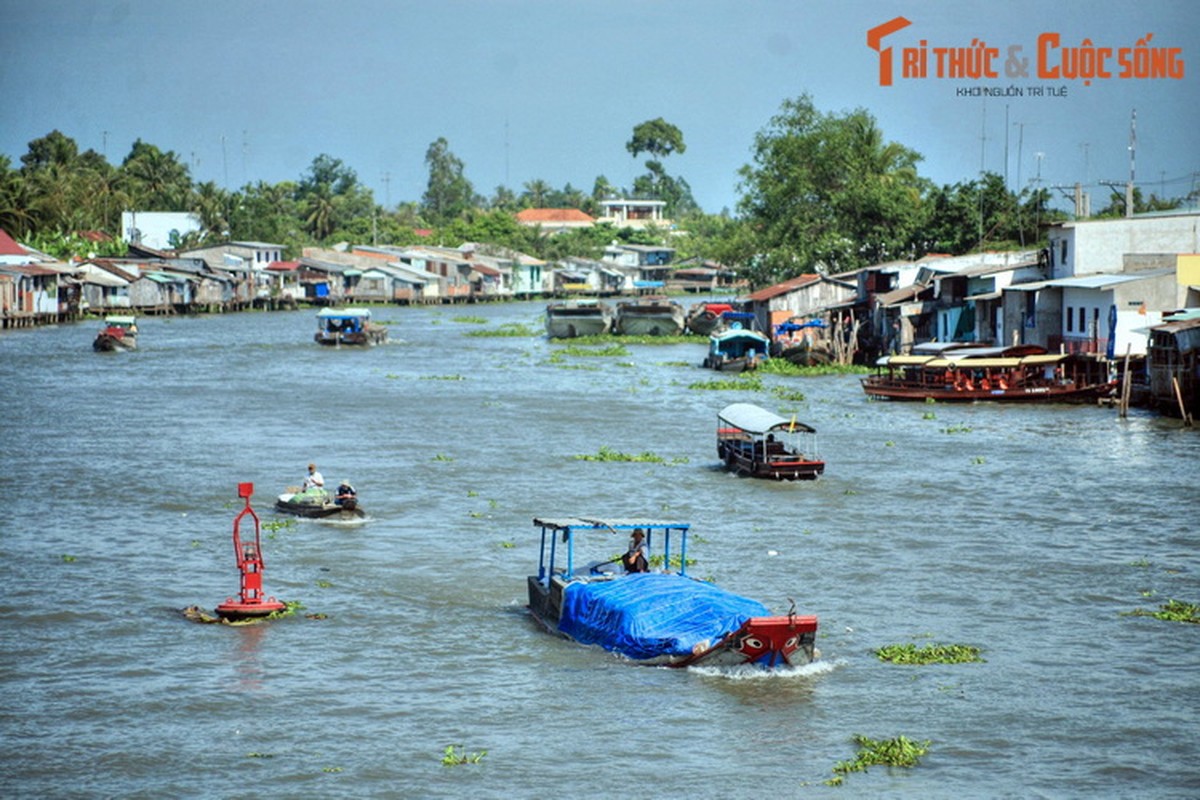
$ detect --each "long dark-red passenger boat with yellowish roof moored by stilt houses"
[862,343,1116,403]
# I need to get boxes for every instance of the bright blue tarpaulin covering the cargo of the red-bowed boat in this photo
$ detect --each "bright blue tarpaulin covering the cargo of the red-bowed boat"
[558,572,770,658]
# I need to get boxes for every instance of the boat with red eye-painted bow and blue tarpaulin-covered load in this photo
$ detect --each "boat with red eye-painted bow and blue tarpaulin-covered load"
[528,517,817,669]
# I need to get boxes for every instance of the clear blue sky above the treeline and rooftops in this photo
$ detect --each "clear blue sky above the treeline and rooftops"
[0,0,1200,212]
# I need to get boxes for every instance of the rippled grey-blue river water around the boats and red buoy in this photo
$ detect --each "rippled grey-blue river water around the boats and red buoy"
[0,303,1200,799]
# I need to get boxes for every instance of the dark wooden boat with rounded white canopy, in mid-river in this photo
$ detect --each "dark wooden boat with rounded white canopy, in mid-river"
[716,403,824,481]
